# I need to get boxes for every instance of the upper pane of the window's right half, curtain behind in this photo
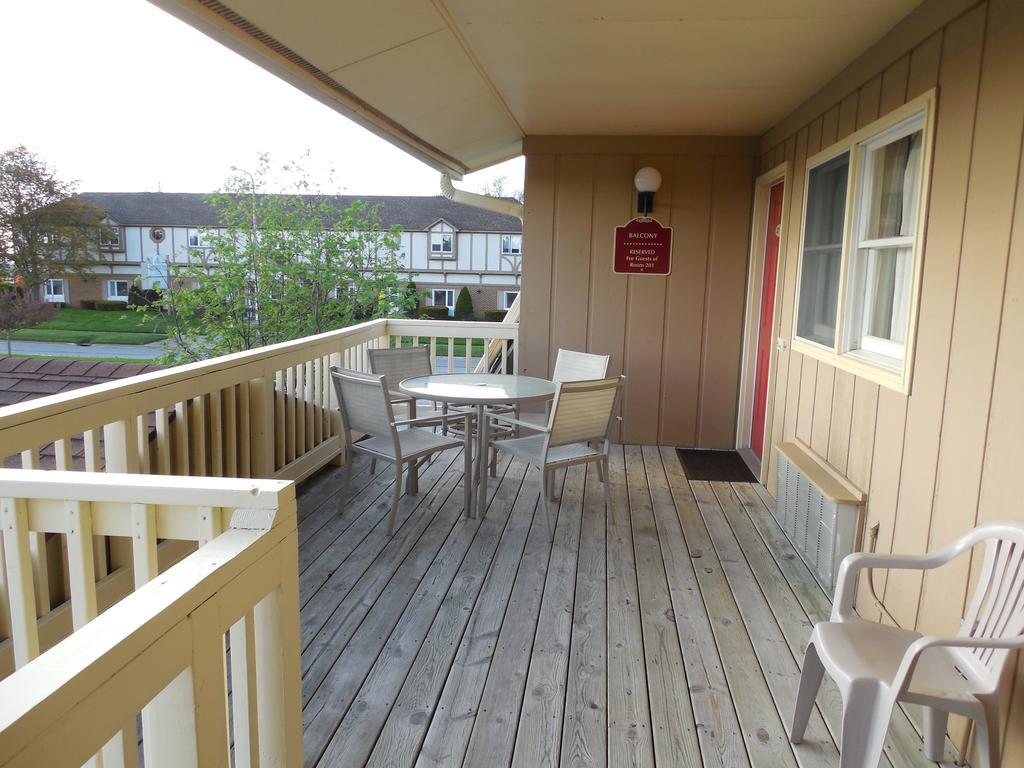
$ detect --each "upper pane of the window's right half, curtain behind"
[863,131,923,240]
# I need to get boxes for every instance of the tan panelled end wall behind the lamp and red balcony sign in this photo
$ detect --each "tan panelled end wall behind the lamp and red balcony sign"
[519,136,756,447]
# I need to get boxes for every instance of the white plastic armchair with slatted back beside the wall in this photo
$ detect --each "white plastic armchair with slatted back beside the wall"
[791,521,1024,768]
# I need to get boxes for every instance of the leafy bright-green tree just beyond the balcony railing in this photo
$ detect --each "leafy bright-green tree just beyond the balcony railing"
[161,155,411,361]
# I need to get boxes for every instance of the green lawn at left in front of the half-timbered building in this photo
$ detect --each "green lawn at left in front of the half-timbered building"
[13,307,167,344]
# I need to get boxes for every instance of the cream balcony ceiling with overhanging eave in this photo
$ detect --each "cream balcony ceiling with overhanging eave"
[154,0,920,174]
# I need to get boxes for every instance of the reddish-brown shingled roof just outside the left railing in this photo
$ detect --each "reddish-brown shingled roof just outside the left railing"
[0,357,164,408]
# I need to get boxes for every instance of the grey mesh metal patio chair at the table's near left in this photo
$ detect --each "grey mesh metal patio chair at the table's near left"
[331,366,473,536]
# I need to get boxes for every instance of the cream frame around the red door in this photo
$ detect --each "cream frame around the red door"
[736,161,793,483]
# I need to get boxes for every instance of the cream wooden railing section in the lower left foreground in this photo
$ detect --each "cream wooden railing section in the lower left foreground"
[0,470,302,768]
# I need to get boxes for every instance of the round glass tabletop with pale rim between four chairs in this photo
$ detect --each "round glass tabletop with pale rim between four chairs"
[398,374,555,406]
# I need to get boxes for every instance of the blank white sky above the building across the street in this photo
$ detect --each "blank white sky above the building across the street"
[0,0,523,195]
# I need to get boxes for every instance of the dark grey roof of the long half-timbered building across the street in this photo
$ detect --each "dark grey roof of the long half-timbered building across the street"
[79,193,522,232]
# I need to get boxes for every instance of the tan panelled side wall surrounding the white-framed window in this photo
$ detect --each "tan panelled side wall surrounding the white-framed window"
[760,0,1024,765]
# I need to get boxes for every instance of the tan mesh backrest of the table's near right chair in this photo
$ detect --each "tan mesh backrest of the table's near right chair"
[548,376,623,446]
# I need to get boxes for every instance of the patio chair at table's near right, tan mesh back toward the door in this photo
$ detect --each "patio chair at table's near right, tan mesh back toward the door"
[488,376,626,540]
